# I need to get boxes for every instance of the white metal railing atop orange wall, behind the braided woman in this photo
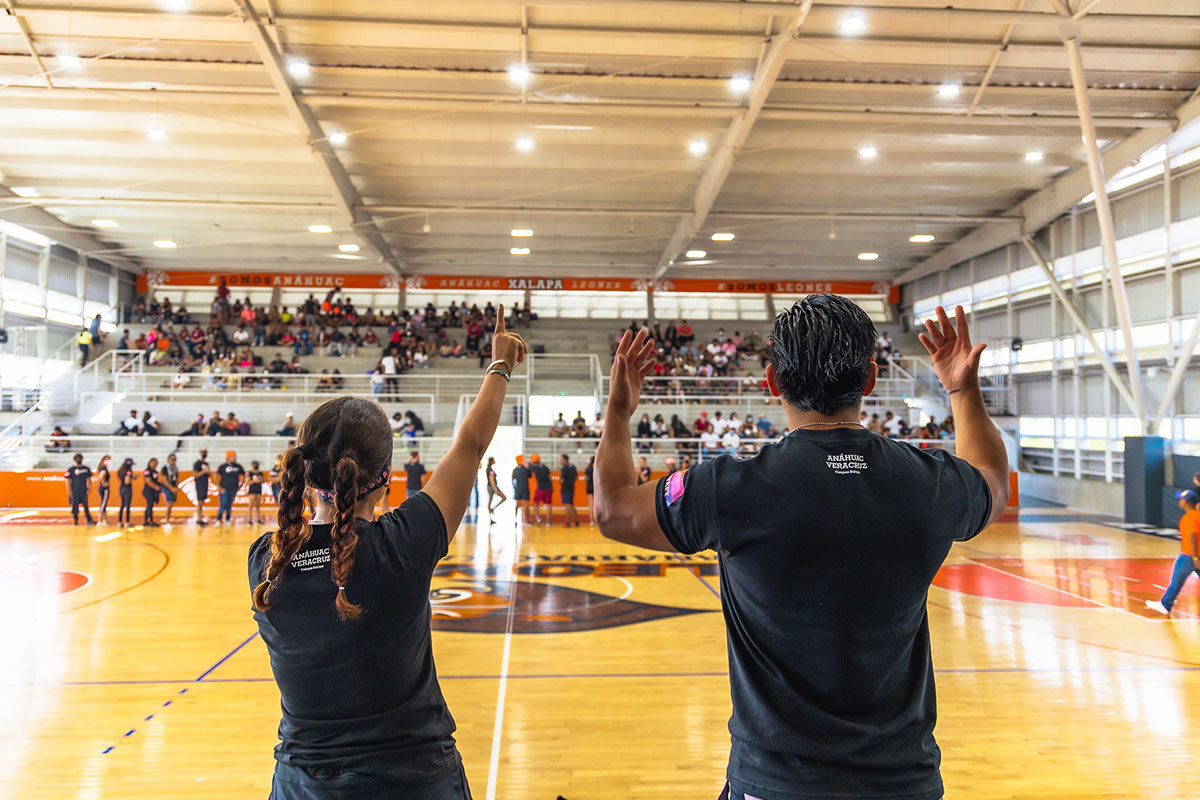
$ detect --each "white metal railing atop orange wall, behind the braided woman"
[8,432,454,475]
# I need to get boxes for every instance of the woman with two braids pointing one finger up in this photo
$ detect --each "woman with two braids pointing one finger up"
[248,303,526,800]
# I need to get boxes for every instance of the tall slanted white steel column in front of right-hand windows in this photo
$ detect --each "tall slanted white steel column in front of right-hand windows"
[1063,36,1147,428]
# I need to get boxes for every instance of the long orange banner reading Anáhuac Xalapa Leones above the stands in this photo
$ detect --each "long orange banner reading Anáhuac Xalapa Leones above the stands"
[138,270,900,302]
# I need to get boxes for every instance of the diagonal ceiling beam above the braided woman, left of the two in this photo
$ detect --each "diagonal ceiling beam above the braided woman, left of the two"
[233,0,403,275]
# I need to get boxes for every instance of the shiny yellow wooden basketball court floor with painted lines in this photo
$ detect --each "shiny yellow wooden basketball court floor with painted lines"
[0,509,1200,800]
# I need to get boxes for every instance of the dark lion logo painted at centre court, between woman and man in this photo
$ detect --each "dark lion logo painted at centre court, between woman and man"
[430,581,710,633]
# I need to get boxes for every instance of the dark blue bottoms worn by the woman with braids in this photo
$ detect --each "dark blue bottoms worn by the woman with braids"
[269,760,470,800]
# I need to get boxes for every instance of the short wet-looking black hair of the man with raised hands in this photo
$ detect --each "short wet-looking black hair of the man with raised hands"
[767,294,876,416]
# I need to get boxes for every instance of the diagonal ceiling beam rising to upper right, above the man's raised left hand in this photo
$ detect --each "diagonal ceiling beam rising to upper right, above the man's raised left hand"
[654,0,814,279]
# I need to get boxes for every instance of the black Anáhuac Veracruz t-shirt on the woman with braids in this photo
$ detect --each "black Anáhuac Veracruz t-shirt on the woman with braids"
[248,493,457,783]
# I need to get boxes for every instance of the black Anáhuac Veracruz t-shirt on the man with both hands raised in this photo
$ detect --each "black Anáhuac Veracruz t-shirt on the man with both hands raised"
[655,429,991,800]
